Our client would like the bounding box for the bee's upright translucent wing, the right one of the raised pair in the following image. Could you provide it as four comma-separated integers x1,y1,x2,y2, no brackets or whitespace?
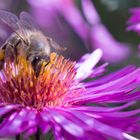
19,11,39,31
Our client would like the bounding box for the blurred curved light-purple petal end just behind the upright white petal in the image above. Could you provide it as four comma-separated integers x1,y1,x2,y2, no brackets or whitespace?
91,24,130,63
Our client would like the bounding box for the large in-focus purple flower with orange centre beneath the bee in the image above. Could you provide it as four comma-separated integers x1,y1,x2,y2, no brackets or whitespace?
0,49,140,140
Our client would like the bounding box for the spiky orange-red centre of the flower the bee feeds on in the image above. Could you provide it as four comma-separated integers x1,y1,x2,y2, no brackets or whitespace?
0,53,79,109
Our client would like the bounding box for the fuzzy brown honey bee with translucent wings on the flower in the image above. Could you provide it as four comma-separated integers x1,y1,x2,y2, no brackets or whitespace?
0,10,64,71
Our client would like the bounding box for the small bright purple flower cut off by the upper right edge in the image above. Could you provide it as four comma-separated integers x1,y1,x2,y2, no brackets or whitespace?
127,7,140,33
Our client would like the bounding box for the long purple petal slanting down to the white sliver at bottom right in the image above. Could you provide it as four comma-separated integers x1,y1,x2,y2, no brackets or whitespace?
55,108,123,139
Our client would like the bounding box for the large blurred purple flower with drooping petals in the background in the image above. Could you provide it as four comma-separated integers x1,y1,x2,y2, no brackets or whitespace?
28,0,129,63
